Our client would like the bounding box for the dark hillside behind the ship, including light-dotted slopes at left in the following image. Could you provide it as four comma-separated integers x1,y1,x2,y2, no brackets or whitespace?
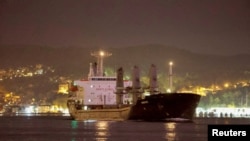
0,45,250,105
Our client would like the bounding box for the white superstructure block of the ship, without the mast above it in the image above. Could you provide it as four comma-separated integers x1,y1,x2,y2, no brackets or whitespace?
74,77,131,105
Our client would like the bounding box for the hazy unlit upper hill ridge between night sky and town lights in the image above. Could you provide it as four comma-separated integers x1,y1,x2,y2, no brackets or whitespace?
0,44,250,81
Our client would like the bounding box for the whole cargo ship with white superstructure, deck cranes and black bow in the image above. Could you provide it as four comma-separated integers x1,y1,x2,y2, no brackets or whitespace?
67,51,201,121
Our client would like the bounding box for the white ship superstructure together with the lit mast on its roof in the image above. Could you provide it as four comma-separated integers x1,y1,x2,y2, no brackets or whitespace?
72,51,132,106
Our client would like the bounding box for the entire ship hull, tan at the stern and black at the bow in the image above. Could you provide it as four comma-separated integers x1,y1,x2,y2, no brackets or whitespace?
68,93,201,121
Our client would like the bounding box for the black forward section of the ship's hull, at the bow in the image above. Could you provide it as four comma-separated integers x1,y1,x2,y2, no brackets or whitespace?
129,93,201,120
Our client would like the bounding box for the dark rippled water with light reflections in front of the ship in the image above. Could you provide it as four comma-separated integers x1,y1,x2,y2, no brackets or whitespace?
0,116,250,141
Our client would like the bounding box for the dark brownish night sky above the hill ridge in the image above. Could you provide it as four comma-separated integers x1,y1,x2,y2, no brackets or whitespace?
0,0,250,54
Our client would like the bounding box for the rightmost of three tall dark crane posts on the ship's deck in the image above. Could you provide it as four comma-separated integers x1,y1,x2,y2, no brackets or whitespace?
149,64,158,94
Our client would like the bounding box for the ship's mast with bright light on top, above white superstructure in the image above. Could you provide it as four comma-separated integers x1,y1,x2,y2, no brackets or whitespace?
91,51,112,76
